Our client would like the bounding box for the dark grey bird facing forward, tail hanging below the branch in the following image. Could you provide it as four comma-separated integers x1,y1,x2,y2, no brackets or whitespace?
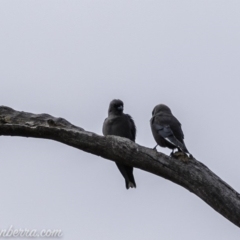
102,99,136,189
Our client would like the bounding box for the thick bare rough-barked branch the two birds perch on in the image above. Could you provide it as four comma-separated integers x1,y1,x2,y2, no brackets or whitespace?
0,106,240,227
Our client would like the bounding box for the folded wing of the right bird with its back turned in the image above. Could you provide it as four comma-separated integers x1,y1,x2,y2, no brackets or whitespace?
153,122,187,152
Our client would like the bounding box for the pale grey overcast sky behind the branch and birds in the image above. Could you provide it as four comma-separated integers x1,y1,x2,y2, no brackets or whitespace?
0,0,240,240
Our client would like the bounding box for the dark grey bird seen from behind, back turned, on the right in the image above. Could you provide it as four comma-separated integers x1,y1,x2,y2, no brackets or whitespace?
150,104,191,156
